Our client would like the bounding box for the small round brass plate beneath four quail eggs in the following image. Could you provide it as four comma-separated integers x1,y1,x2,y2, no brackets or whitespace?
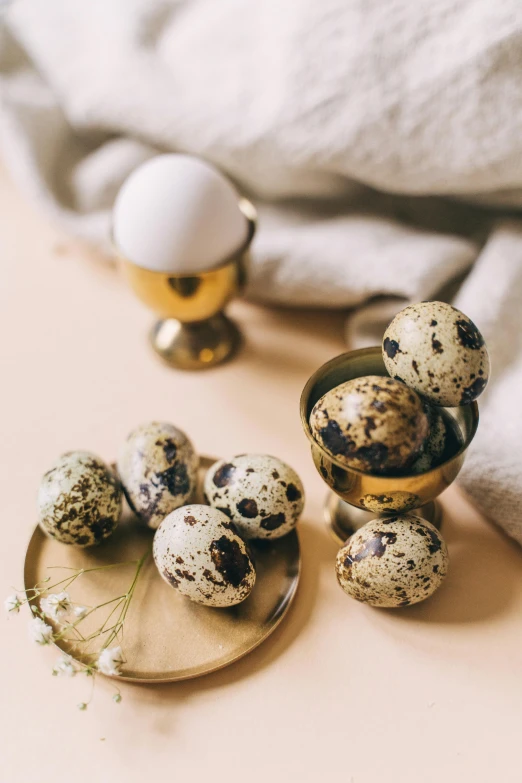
24,457,301,683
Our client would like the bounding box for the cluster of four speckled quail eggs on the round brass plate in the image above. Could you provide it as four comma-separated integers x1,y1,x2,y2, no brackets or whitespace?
38,422,304,607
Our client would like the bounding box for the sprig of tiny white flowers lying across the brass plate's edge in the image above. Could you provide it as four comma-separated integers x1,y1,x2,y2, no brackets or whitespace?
4,549,150,711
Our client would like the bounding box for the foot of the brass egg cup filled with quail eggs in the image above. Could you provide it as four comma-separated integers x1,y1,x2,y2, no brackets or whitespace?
324,492,442,544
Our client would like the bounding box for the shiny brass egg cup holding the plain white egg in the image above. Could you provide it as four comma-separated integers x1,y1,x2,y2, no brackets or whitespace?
119,198,256,370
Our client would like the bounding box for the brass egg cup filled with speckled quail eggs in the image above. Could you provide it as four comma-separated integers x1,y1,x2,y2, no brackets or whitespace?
300,347,479,542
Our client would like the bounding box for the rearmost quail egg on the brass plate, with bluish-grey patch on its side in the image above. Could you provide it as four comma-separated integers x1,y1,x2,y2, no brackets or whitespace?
118,421,199,529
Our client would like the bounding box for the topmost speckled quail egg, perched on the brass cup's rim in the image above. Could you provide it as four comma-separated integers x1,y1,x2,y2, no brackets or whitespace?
383,302,490,407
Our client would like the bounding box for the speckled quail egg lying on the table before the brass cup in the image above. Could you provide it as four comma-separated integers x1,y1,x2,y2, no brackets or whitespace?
335,514,449,607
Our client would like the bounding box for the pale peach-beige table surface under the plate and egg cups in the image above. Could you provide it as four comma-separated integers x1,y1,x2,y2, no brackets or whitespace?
0,164,522,783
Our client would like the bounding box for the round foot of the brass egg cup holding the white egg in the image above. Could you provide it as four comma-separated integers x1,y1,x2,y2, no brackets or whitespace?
149,313,242,370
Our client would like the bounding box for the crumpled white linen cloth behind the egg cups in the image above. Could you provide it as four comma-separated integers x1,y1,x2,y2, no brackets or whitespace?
0,0,522,543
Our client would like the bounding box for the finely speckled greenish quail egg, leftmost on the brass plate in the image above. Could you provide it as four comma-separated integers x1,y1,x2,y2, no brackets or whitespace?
38,451,122,547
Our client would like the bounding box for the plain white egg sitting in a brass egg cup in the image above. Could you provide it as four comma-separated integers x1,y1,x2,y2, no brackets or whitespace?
113,155,248,274
